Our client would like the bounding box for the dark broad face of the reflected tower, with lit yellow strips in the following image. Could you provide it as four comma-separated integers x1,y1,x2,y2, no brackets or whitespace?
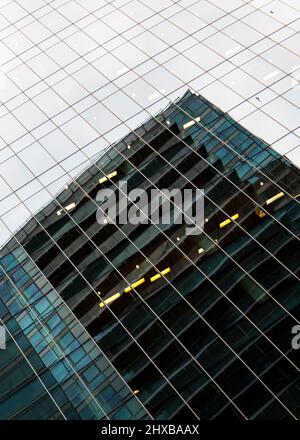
3,92,300,419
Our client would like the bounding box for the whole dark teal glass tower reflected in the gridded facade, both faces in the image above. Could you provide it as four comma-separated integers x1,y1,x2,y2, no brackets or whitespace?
0,91,300,420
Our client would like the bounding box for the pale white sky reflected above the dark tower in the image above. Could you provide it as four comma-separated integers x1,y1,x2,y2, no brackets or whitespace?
0,0,300,243
